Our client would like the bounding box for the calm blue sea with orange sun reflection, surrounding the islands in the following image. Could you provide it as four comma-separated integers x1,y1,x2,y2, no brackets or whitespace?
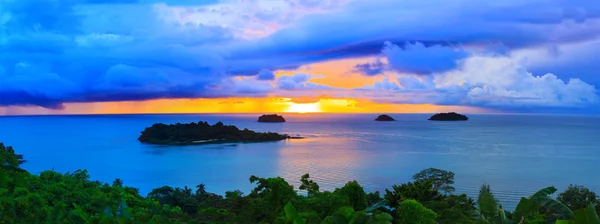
0,114,600,209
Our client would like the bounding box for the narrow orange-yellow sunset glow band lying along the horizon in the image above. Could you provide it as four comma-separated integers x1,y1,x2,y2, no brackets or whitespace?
0,98,502,115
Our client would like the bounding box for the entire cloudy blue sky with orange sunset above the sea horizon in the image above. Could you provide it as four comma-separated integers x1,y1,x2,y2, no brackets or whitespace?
0,0,600,115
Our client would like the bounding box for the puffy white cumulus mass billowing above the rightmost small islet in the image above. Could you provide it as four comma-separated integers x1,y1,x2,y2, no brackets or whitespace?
436,56,599,107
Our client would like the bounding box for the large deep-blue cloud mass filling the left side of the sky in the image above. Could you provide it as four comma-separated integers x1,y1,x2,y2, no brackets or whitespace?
0,0,356,108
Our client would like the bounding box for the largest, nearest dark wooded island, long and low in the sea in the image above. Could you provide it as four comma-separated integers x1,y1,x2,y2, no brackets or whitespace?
138,122,292,145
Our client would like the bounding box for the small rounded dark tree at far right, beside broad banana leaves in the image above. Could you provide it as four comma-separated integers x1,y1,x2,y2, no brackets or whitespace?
556,184,600,213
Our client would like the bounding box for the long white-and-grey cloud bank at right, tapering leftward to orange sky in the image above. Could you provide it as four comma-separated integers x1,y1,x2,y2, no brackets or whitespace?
357,51,600,111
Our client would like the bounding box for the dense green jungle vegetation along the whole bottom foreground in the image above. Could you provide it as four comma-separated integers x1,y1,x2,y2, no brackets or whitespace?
0,143,600,224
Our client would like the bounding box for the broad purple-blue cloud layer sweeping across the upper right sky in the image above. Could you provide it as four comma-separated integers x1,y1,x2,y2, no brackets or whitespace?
232,0,600,72
